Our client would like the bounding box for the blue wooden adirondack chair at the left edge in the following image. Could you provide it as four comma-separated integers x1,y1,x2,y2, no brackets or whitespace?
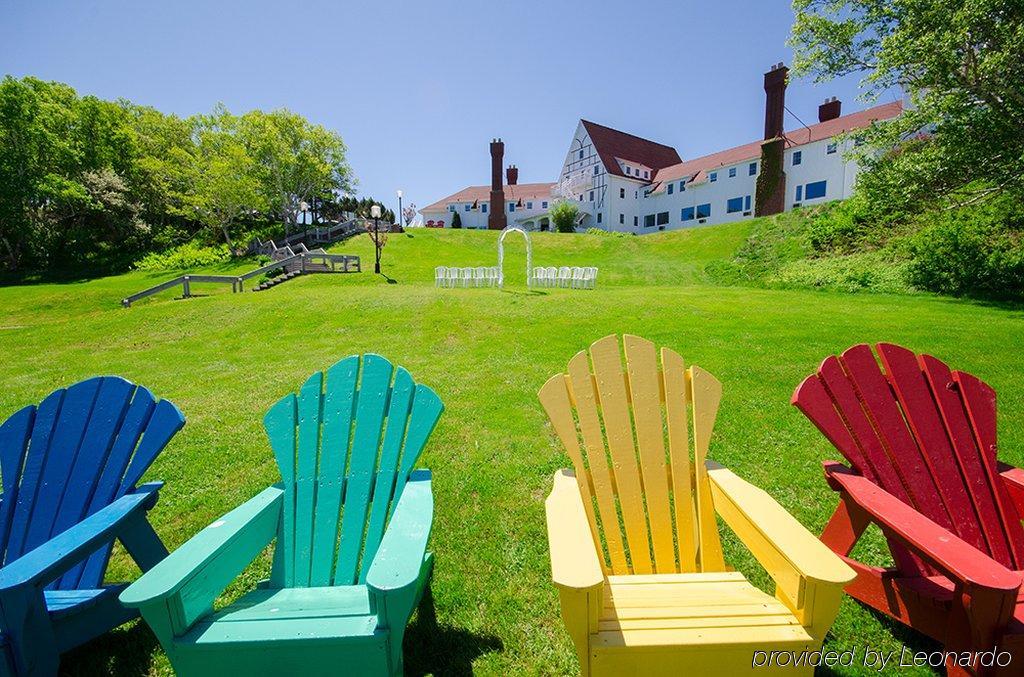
0,376,185,675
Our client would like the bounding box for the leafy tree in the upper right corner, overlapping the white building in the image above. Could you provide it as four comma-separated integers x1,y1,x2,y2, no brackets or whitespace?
790,0,1024,211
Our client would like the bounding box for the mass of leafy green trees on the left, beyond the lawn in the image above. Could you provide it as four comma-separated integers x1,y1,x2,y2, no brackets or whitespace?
0,76,356,270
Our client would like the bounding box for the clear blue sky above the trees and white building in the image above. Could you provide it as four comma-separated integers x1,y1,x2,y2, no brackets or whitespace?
0,0,891,215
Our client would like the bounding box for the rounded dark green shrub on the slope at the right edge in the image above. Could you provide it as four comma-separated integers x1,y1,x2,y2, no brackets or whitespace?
907,199,1024,299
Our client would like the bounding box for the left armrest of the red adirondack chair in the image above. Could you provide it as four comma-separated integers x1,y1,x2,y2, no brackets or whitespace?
824,462,1021,595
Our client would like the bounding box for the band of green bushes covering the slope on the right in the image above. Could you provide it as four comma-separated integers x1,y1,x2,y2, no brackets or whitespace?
707,195,1024,301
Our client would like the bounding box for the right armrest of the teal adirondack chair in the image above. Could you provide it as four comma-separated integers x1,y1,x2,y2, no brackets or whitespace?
367,470,434,594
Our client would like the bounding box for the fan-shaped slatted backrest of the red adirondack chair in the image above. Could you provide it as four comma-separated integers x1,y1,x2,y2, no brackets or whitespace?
793,344,1024,576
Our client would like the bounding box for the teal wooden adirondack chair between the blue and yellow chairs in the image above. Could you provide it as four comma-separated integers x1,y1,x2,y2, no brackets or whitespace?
121,354,443,677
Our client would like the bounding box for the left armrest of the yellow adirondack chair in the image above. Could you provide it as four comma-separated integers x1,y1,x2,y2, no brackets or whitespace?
544,470,604,590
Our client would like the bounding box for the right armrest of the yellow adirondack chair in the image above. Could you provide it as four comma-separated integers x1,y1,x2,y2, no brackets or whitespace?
707,461,856,636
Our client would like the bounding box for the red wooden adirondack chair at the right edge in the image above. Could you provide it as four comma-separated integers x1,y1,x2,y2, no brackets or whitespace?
793,343,1024,674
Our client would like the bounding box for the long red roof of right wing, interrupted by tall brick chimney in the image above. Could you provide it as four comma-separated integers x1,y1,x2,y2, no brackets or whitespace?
651,101,903,189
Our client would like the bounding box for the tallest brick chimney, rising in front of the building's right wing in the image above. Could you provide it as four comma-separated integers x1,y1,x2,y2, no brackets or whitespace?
754,64,790,216
